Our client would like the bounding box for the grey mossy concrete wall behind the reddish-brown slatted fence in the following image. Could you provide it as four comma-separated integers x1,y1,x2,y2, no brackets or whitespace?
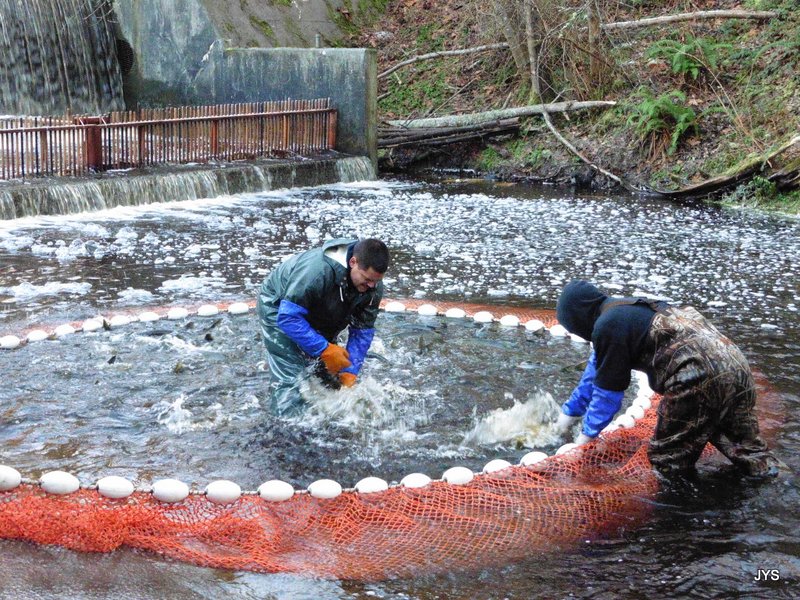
114,0,377,169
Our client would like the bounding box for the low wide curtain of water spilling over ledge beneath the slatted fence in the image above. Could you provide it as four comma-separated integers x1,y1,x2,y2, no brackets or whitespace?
0,156,375,220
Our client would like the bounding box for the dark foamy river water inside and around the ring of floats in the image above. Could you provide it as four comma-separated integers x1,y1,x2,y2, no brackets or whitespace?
0,179,800,599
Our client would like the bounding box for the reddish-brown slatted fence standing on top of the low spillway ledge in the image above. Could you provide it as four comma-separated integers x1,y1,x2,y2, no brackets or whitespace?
0,98,337,179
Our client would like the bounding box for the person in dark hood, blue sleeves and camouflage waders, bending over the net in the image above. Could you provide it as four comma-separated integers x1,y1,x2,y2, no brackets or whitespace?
556,280,783,476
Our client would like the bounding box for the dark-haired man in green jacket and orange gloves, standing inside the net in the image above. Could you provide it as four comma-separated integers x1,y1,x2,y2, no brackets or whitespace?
258,238,389,415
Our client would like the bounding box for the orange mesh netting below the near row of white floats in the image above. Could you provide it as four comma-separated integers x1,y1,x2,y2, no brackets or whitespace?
0,404,657,580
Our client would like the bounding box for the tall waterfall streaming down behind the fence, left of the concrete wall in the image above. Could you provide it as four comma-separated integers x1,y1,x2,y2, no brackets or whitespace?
0,0,124,115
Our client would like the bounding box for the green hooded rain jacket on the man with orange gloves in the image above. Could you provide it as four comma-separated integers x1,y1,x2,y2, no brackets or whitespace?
259,238,383,342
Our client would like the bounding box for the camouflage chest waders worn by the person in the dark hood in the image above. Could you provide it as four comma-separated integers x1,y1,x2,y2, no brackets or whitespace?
604,300,780,476
